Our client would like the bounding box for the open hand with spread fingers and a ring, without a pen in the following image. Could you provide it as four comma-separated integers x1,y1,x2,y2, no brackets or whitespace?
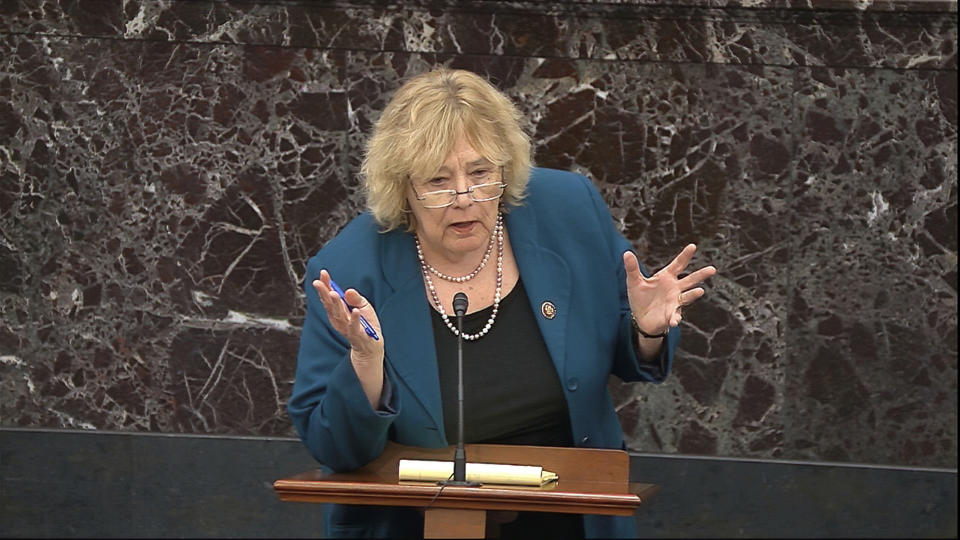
623,244,717,335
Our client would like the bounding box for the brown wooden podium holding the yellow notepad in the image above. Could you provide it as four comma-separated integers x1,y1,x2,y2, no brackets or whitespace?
273,443,659,538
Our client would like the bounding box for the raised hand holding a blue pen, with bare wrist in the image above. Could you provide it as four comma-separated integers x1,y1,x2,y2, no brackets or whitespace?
312,270,384,409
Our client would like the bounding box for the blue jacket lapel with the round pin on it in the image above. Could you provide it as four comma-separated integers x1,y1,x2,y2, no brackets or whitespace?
505,205,572,378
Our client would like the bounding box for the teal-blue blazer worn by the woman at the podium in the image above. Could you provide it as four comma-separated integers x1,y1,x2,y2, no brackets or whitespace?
287,169,680,537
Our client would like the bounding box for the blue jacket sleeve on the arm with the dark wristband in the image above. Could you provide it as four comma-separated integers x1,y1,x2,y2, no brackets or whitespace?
580,176,680,383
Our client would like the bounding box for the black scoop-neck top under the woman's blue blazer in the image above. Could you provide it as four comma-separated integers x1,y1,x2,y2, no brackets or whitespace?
433,280,573,446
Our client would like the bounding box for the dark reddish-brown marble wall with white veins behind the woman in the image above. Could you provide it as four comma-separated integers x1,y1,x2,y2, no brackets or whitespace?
0,0,957,468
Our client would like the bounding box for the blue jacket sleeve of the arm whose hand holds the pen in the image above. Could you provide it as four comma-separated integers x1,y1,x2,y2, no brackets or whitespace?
287,256,400,471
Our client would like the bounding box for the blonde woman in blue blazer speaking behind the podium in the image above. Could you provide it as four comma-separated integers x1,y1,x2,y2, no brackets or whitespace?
288,68,715,537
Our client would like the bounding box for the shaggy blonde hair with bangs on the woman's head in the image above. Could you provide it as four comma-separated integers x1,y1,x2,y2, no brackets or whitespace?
361,67,532,231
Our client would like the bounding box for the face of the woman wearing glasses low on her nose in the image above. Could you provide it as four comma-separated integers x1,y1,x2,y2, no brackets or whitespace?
407,137,502,264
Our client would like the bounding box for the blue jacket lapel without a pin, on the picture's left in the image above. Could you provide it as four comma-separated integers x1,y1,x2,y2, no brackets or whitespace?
376,230,446,441
